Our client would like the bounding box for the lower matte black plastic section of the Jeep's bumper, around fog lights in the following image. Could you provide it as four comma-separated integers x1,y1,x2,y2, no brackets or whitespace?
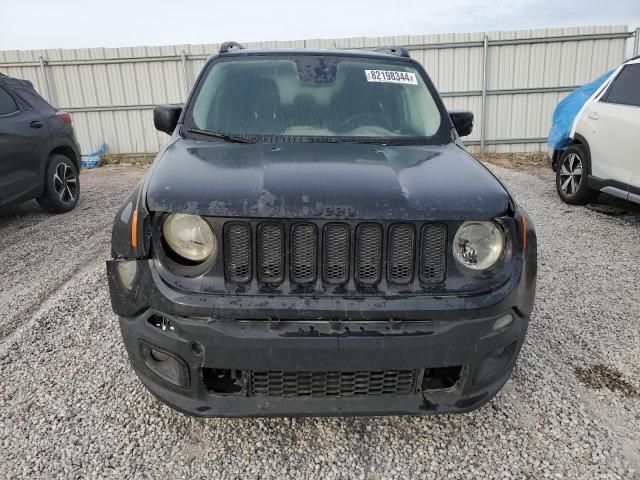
120,311,528,416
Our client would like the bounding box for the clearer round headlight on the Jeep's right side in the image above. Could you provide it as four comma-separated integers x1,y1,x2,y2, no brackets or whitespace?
453,222,505,270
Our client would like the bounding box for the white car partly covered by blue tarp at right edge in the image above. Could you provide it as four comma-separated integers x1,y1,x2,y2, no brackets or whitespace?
551,57,640,204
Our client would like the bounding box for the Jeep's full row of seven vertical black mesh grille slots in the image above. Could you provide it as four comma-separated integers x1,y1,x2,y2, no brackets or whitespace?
222,220,447,293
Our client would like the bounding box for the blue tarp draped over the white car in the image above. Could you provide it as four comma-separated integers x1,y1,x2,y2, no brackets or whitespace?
547,70,613,150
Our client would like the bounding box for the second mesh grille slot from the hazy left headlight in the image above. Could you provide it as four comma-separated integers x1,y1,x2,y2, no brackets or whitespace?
258,223,284,285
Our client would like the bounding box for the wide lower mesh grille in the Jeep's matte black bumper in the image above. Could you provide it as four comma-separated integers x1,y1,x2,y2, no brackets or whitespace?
249,370,418,397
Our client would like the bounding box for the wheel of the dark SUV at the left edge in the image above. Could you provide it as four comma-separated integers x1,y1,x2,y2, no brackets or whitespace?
38,155,80,213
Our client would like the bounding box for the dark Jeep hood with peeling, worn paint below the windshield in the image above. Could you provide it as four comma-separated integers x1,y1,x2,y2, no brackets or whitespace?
146,140,509,220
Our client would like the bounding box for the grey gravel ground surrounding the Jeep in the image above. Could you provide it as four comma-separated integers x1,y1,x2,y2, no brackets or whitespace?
0,166,640,479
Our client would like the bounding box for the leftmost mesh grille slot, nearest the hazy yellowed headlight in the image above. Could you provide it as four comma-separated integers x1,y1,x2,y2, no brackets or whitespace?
224,222,252,283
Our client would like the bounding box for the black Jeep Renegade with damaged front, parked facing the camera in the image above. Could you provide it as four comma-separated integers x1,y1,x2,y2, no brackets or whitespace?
107,43,536,416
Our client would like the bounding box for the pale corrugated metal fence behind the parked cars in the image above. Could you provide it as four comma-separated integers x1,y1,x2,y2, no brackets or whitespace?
0,26,640,153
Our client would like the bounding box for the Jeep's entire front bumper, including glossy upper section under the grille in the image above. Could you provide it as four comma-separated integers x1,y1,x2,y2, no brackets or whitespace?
107,260,535,416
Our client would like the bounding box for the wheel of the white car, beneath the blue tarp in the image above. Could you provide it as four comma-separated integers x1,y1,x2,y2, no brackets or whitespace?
556,145,598,205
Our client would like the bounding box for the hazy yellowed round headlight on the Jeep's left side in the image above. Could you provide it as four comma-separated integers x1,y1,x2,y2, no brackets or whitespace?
162,213,218,262
